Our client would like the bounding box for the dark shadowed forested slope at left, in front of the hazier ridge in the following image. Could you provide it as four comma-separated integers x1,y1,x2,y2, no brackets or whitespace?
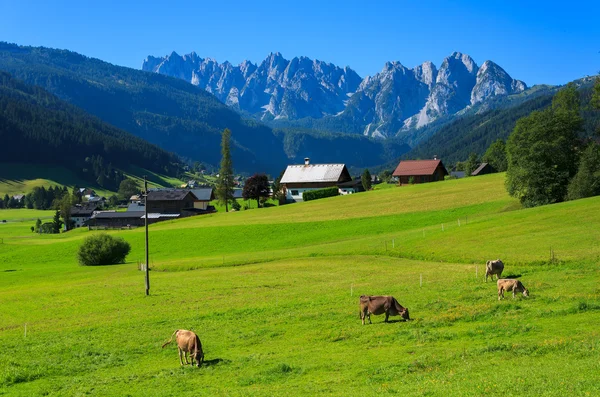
0,72,180,190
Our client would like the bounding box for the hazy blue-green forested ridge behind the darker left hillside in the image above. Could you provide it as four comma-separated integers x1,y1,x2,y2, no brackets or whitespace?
0,43,407,174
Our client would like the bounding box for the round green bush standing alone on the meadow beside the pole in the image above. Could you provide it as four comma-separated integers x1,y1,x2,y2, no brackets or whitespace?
77,233,131,266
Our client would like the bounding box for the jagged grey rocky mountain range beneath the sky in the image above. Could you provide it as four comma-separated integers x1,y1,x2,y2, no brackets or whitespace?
142,52,527,138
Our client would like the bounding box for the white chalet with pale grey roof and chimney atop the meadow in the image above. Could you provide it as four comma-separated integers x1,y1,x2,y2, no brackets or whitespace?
281,157,352,202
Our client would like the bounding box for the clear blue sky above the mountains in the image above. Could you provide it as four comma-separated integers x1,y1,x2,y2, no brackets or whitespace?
0,0,600,85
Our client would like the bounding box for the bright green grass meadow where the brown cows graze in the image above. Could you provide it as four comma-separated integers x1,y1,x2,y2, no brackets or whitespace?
0,174,600,396
